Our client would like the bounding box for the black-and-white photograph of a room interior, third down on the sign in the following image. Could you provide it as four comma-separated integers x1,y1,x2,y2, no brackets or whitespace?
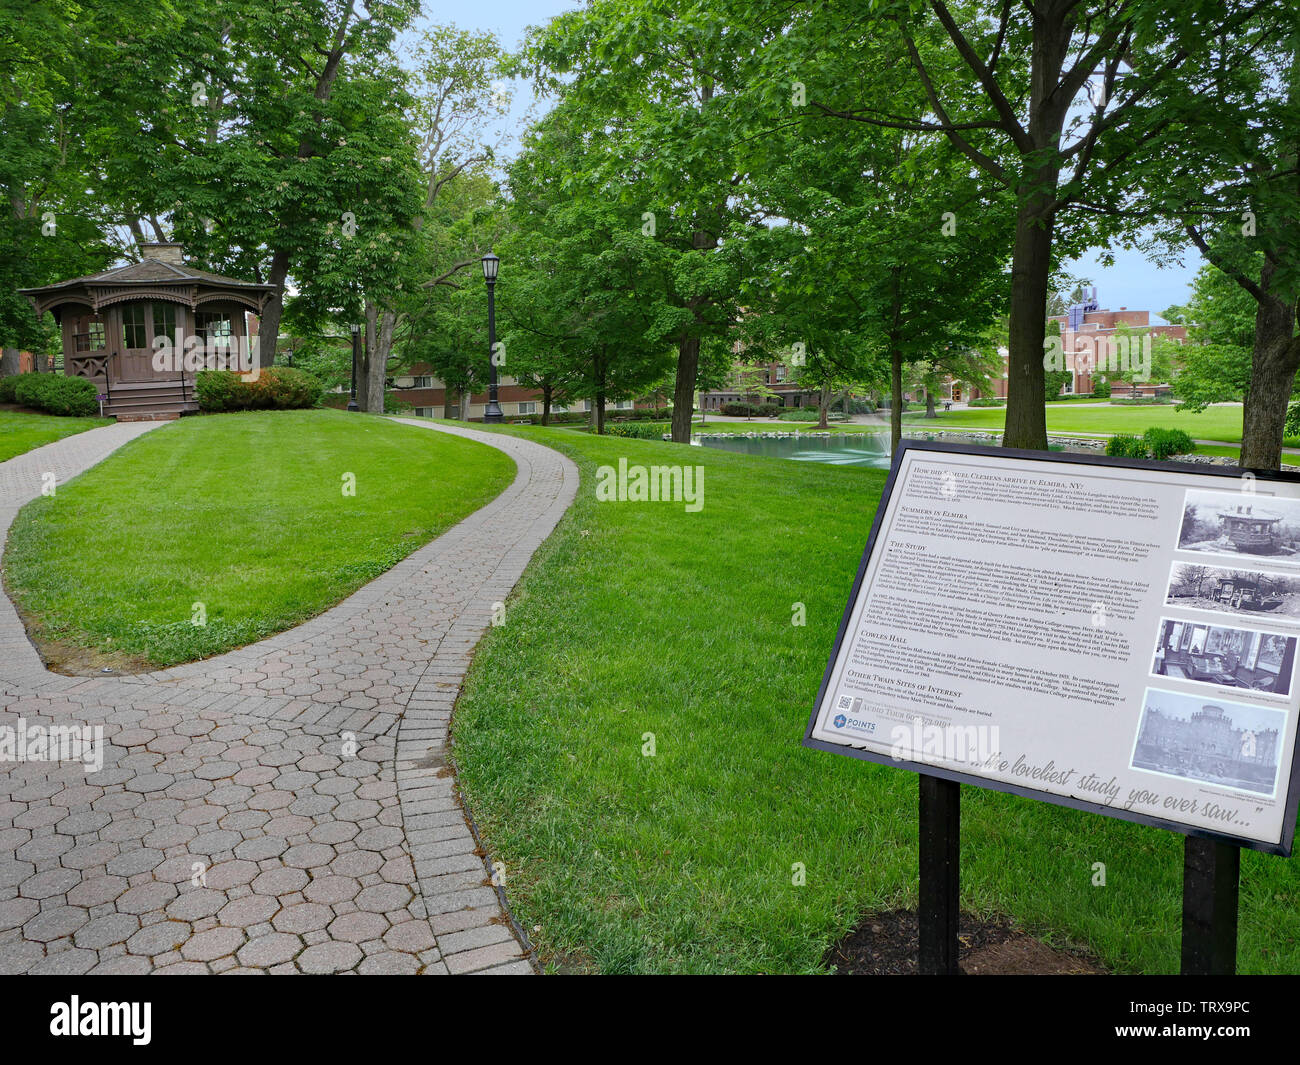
1151,618,1296,696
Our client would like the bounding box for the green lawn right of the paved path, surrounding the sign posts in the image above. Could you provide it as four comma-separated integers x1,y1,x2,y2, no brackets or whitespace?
454,429,1300,973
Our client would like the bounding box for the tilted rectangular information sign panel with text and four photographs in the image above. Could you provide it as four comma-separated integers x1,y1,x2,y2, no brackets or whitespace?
805,441,1300,854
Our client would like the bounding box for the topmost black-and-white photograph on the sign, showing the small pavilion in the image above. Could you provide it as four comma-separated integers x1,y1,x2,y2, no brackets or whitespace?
1178,481,1300,566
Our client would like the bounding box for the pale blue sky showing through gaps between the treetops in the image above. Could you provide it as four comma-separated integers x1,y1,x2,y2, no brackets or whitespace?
410,0,1203,322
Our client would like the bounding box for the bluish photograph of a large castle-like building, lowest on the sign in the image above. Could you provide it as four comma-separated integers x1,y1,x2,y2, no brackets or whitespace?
1132,688,1287,796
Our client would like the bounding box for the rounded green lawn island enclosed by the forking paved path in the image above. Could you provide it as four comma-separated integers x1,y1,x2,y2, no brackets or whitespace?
4,411,515,667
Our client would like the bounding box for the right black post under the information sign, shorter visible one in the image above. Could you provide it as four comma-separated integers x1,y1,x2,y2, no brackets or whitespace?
1183,836,1242,977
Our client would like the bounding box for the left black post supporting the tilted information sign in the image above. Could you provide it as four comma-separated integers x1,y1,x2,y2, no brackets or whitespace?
918,774,962,975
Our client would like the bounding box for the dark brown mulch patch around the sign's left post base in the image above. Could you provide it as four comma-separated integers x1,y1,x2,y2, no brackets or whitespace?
823,910,1106,977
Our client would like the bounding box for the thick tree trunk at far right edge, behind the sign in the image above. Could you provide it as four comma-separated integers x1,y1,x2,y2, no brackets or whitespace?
1240,259,1300,469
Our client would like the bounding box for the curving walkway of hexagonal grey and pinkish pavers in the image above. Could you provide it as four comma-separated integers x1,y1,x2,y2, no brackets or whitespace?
0,419,577,974
